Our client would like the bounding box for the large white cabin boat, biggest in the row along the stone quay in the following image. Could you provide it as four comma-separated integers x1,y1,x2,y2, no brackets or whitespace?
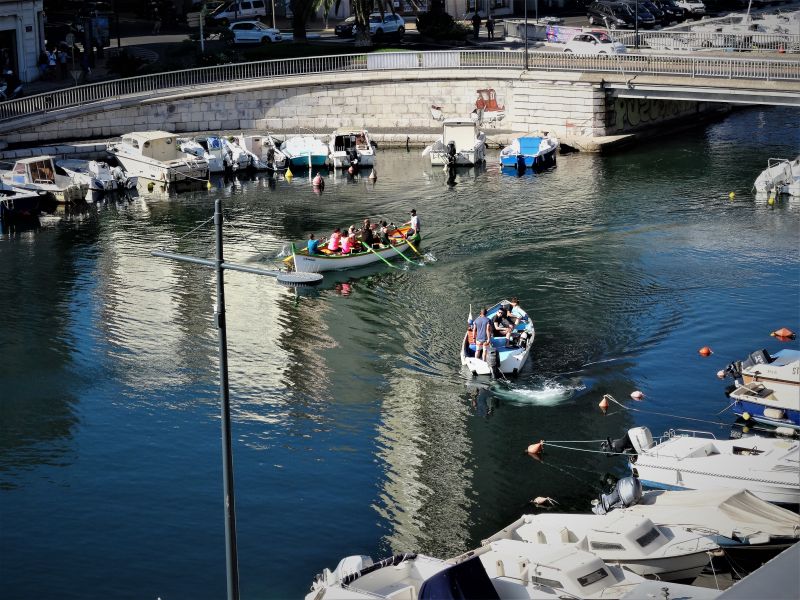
108,131,208,185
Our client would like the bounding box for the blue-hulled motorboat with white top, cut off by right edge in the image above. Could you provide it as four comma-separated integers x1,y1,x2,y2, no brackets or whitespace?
722,348,800,429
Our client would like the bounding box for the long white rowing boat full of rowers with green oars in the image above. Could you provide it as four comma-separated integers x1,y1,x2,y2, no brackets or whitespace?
284,210,422,273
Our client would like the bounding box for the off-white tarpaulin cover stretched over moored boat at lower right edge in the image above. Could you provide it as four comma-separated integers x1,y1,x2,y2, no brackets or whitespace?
623,489,800,543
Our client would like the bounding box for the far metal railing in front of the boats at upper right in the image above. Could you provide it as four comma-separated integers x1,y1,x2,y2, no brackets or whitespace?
615,31,800,52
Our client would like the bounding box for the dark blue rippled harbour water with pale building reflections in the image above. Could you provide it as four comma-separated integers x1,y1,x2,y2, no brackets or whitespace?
0,109,800,600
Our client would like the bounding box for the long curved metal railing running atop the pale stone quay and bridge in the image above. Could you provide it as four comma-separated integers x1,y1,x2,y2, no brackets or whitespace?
0,50,800,122
